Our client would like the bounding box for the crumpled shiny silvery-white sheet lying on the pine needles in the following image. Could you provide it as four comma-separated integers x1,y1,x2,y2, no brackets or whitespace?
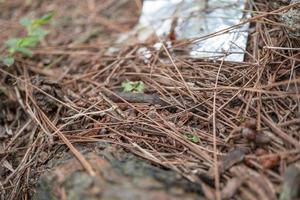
123,0,250,62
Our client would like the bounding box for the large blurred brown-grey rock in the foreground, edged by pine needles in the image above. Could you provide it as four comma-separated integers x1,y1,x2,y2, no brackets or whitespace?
33,147,203,200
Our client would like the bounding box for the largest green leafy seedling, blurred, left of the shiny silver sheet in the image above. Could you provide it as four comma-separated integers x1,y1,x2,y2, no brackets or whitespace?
1,12,54,66
